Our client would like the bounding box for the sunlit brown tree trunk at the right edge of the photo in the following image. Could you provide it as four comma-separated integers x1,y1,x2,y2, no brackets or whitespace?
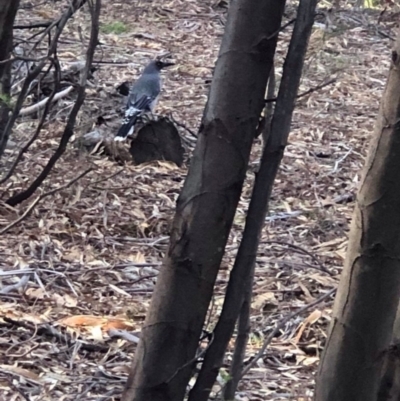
315,32,400,401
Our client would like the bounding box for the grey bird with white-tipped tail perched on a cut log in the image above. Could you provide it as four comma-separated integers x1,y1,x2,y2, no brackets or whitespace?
114,60,174,141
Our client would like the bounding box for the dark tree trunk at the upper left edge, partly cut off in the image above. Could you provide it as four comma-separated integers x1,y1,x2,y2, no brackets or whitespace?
0,0,19,158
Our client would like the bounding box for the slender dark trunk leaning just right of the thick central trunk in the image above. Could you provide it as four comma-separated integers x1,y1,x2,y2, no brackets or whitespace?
189,0,317,401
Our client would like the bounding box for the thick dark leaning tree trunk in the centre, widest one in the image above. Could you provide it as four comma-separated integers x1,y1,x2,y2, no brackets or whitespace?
123,0,284,401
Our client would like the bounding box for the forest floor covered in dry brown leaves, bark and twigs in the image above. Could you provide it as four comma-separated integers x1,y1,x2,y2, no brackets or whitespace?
0,0,395,401
